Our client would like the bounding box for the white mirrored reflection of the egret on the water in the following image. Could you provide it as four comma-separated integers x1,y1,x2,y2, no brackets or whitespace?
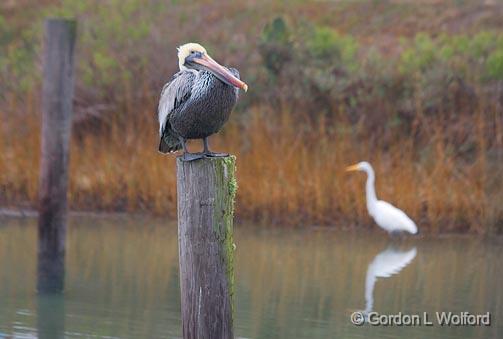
364,245,417,314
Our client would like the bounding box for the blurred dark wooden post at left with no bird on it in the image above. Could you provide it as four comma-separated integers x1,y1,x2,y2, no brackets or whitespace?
37,19,76,293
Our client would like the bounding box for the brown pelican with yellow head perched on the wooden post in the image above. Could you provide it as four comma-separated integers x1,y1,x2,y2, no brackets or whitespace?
158,43,248,161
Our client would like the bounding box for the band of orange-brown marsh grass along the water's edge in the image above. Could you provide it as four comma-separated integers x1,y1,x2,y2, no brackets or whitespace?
0,97,503,233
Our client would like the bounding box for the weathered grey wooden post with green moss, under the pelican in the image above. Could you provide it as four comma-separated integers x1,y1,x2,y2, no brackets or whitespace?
177,156,237,339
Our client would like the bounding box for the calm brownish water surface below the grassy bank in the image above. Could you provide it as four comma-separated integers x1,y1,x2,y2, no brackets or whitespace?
0,217,503,338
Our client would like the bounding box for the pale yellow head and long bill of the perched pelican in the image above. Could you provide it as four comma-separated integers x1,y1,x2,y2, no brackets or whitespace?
178,42,248,92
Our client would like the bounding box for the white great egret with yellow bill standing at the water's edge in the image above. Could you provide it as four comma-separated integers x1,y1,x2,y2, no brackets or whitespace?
346,161,417,234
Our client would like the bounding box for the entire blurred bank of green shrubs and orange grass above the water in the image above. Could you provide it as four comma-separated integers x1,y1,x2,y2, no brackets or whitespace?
0,0,503,233
